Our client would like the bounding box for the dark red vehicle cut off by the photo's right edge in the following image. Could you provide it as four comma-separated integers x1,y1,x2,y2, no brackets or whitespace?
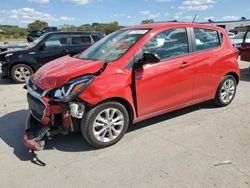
240,26,250,61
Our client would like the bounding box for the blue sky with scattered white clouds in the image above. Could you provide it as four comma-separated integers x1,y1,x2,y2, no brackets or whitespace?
0,0,250,27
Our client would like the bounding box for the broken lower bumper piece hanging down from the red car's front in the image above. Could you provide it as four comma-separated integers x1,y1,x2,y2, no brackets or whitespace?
23,114,50,151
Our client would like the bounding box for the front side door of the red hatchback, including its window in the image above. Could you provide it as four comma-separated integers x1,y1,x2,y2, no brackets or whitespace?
135,28,194,117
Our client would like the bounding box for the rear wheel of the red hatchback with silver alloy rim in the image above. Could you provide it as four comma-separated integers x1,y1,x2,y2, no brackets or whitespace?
214,75,237,107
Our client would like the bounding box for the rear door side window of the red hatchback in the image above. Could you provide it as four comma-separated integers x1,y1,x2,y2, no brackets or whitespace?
194,28,221,51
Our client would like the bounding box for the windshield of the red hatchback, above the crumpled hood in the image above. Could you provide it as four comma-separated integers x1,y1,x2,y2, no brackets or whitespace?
77,29,148,61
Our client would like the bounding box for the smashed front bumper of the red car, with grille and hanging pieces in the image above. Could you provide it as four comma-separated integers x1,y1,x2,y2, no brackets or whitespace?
23,78,74,151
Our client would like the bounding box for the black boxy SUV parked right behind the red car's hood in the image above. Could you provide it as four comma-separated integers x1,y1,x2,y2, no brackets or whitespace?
0,32,104,83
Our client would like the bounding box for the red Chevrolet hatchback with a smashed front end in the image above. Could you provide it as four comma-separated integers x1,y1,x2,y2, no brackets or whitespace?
24,22,240,150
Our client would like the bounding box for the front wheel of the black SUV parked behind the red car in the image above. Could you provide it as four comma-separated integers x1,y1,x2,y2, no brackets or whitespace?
10,64,34,83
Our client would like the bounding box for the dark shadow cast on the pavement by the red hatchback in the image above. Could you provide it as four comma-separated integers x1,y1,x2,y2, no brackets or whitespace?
0,102,214,161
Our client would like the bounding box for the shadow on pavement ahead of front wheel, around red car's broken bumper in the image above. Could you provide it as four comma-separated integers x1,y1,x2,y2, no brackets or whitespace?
0,110,93,161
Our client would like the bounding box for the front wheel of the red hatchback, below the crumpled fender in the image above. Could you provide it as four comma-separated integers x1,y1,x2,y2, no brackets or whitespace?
81,102,129,148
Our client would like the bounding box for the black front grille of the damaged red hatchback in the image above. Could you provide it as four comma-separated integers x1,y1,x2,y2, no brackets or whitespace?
27,93,46,121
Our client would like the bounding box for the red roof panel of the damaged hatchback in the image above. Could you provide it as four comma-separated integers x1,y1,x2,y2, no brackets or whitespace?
124,22,224,31
